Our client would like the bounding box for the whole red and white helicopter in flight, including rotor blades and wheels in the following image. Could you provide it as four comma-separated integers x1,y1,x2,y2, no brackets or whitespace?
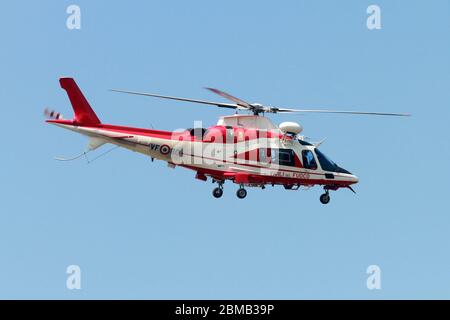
45,78,409,204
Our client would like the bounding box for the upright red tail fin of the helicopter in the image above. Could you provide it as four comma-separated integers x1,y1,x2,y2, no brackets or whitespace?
59,78,100,125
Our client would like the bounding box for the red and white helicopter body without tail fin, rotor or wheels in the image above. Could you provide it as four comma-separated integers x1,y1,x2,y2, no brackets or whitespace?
48,116,358,190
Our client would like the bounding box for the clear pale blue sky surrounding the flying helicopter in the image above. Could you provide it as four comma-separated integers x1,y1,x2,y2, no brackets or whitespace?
0,0,450,299
